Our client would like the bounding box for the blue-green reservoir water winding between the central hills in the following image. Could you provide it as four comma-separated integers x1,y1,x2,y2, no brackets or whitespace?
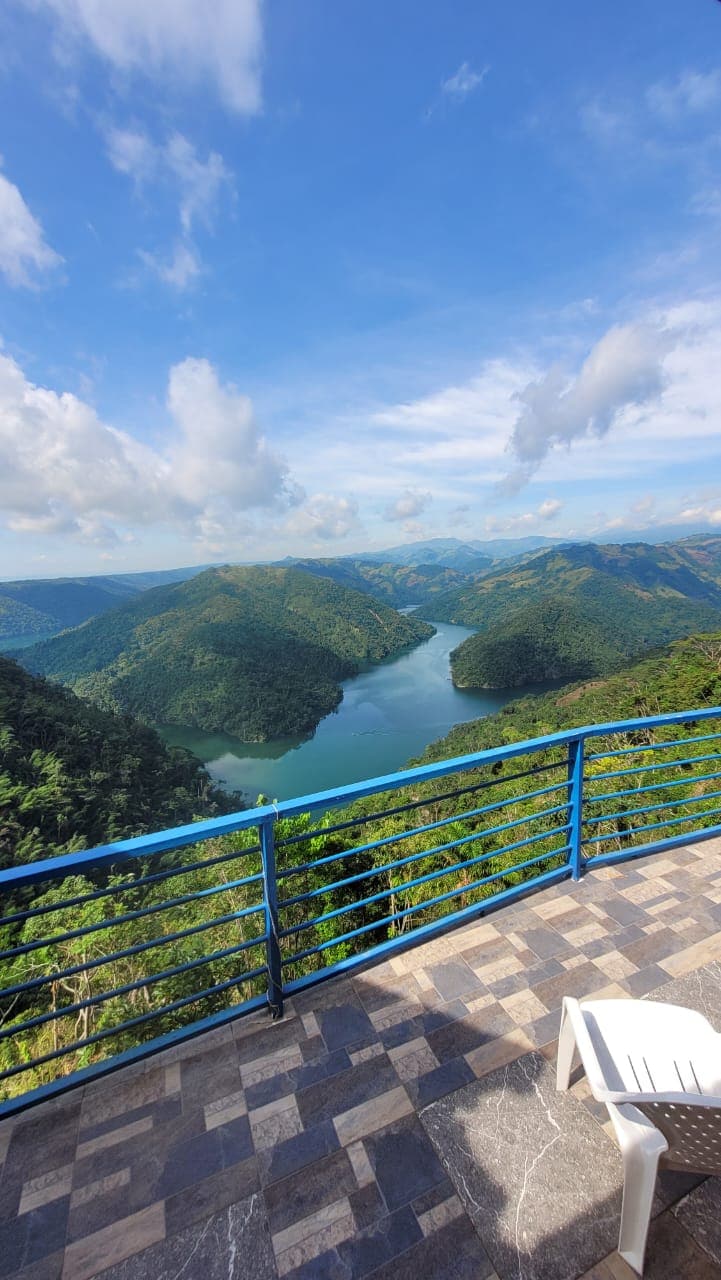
160,622,537,804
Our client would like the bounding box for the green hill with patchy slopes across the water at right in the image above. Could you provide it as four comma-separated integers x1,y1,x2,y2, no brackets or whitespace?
421,538,721,687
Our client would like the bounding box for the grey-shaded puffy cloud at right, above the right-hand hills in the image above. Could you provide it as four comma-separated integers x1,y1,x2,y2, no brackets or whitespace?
503,324,671,493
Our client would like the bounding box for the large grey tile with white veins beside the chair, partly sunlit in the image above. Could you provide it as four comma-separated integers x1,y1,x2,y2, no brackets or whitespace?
421,1053,622,1280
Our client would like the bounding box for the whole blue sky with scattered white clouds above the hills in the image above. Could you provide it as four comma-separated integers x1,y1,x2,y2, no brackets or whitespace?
0,0,721,577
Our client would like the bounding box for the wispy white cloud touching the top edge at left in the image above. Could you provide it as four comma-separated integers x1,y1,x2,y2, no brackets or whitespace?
26,0,263,115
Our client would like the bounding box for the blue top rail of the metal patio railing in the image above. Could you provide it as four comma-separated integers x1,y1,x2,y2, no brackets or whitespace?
0,707,721,891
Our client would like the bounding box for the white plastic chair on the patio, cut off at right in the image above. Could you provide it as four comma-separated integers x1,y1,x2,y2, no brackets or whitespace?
556,996,721,1275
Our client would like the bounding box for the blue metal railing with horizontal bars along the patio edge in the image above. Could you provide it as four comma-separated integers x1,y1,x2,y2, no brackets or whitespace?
0,708,721,1114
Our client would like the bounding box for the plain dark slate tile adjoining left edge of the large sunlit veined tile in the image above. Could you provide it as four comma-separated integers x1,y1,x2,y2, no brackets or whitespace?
364,1116,446,1211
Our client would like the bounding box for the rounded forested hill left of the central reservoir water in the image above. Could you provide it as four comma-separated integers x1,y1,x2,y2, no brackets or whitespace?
20,566,433,741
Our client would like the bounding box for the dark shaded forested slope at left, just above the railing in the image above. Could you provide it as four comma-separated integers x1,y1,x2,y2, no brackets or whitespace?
0,657,233,867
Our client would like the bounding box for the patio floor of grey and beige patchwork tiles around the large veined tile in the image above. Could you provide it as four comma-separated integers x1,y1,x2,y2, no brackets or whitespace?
0,841,721,1280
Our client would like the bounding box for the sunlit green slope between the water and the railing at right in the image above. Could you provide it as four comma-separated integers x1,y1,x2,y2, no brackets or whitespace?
412,631,721,764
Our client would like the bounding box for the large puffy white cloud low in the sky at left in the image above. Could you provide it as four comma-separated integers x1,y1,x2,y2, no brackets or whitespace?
0,355,291,541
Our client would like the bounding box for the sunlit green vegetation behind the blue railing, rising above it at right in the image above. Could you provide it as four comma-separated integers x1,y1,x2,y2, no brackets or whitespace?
0,632,721,1093
